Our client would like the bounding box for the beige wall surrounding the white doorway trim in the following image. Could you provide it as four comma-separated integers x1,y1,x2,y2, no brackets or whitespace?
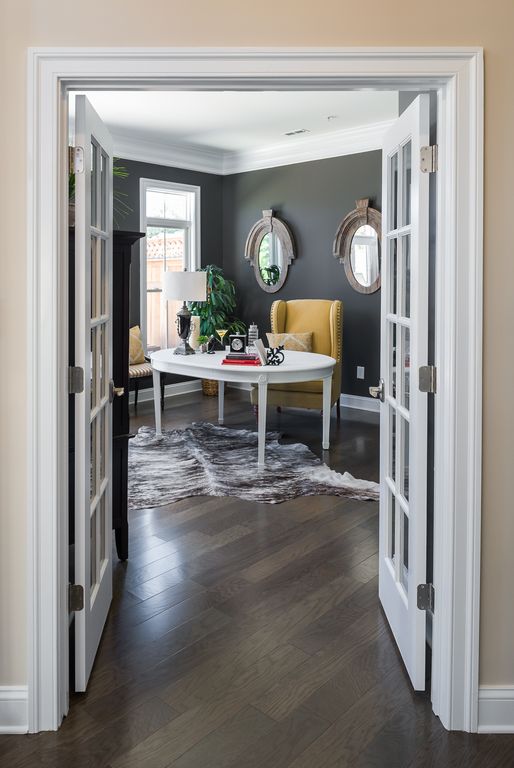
0,0,514,685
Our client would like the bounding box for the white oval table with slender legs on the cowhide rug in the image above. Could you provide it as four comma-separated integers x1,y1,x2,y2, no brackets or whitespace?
150,349,336,467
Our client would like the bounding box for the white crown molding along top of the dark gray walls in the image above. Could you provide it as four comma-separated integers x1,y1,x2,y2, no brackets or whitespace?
112,120,394,176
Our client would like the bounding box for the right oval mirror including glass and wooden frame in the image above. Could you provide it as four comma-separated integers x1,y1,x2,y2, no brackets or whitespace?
333,198,382,293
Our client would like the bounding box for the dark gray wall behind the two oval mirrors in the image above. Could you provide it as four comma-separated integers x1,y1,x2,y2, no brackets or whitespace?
223,151,382,395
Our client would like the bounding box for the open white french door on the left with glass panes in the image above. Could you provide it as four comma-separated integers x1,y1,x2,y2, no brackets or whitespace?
75,96,112,691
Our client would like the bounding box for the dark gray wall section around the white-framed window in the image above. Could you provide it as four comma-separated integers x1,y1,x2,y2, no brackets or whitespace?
114,159,223,325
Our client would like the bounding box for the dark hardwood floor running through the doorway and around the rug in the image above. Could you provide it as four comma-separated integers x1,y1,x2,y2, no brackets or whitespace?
4,390,514,768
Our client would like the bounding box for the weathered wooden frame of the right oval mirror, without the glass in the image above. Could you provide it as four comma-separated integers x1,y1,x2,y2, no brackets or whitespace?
333,197,382,293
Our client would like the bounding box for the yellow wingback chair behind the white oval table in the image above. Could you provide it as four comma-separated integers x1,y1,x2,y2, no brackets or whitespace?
251,299,343,419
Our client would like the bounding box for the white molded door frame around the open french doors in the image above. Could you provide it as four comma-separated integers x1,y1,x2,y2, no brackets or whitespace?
27,48,483,732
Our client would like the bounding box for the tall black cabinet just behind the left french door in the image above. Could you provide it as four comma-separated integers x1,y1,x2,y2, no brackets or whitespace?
112,230,144,560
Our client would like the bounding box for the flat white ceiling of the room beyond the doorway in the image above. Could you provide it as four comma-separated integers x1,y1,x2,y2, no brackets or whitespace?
74,91,398,152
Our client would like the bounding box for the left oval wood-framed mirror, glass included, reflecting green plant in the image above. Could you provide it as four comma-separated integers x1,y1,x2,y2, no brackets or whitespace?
245,209,296,293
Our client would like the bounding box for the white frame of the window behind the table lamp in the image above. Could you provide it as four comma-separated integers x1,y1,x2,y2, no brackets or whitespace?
139,178,201,352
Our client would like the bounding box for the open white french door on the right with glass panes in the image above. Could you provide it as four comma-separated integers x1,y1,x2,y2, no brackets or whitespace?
379,95,430,690
